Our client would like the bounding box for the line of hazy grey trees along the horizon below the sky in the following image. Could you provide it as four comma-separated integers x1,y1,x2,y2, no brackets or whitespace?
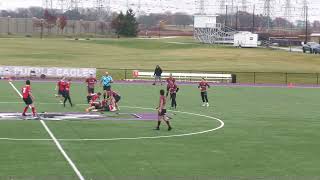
0,7,320,35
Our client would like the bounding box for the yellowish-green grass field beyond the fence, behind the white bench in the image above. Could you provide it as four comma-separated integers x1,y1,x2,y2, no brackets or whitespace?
0,38,320,73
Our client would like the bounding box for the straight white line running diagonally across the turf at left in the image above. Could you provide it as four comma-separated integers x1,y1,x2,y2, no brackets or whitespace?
9,82,85,180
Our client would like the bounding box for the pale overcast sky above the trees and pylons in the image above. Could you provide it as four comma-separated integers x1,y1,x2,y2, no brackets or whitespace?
0,0,320,20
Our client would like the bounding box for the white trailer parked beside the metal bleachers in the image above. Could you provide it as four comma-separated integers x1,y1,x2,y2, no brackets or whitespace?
233,31,258,47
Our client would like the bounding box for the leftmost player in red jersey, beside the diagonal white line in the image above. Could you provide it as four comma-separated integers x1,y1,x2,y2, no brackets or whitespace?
22,80,36,117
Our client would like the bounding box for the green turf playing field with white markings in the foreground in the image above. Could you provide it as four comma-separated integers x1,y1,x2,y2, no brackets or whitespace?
0,81,320,180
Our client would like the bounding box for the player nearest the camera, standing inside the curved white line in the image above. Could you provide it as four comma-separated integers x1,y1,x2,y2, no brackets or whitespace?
155,89,172,131
